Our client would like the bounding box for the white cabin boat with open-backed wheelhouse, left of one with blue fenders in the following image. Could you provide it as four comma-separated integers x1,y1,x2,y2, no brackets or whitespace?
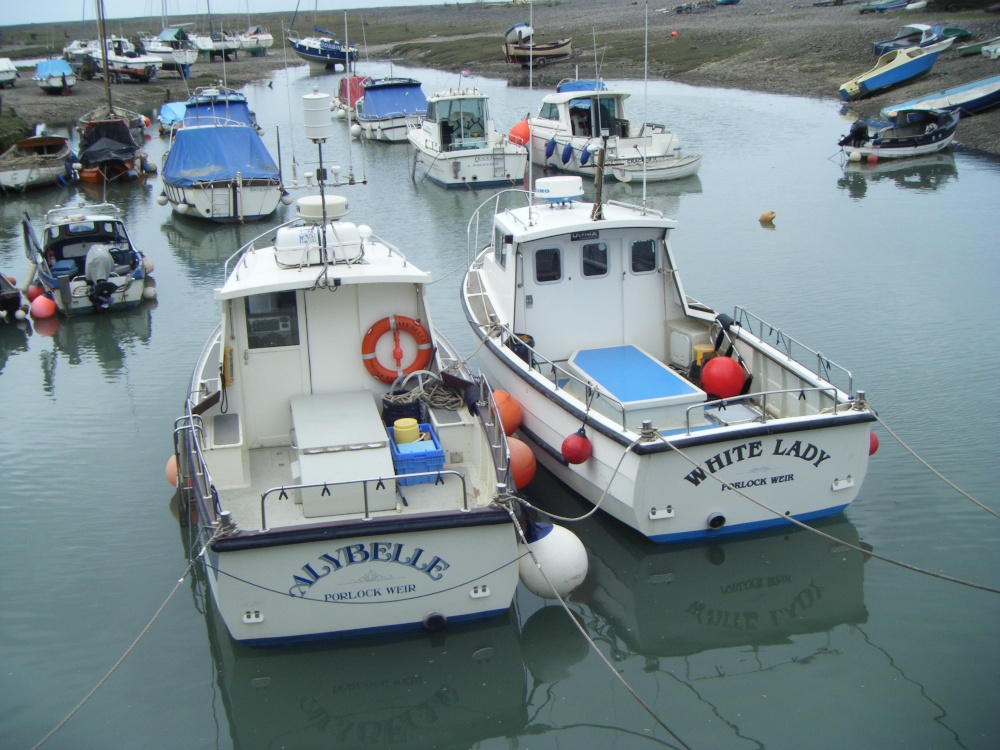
407,88,528,187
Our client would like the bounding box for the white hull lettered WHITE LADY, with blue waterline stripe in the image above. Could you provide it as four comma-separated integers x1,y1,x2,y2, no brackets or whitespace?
477,343,871,543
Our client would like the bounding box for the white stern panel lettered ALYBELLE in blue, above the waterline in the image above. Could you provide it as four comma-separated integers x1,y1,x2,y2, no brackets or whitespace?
199,511,518,646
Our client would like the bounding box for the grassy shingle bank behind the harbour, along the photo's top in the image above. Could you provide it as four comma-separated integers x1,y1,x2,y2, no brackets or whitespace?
0,0,1000,155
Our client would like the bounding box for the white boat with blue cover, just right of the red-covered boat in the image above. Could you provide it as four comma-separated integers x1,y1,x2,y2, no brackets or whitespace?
352,78,427,143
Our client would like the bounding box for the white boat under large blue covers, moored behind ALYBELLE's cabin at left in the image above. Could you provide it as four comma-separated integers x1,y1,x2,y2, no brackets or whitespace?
159,88,287,222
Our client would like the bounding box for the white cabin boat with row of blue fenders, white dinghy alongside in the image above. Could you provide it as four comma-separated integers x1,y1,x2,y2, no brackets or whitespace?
514,80,701,182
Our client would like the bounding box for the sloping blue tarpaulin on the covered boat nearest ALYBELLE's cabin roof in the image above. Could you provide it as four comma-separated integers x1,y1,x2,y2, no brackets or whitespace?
163,122,279,187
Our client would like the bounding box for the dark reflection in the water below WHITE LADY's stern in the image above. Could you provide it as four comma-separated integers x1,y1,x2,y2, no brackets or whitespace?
528,470,868,674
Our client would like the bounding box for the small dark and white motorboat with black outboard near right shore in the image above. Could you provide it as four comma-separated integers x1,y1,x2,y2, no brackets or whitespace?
837,109,960,161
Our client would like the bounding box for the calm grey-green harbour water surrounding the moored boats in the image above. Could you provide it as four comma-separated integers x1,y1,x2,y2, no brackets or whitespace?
0,65,1000,750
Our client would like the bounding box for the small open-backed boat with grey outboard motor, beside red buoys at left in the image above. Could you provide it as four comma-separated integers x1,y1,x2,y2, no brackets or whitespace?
22,203,155,316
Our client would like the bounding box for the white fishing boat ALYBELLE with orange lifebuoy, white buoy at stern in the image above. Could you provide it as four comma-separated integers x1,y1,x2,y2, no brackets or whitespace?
168,93,586,645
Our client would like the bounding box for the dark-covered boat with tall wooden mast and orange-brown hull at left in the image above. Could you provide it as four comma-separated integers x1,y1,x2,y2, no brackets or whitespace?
77,0,155,182
